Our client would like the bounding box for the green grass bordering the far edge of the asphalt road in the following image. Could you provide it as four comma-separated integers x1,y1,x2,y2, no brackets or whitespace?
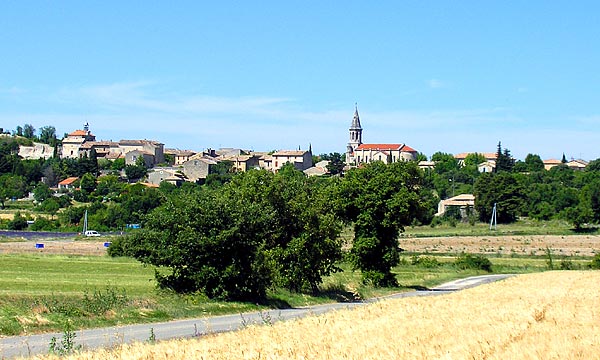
0,250,556,336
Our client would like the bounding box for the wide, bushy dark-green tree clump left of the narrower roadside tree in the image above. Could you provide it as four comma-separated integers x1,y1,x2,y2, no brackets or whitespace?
111,167,341,301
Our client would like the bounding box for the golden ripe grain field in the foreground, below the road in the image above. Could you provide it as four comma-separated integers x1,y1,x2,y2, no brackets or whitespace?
37,271,600,359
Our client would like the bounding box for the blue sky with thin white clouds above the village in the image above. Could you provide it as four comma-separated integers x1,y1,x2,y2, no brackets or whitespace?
0,0,600,160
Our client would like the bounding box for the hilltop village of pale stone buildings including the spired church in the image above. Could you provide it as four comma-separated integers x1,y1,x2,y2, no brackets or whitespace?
9,107,588,188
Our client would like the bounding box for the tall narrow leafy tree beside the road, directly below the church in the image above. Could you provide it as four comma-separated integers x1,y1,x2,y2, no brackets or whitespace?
336,162,429,286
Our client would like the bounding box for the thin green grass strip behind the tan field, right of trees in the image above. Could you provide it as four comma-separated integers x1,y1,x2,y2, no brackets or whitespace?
401,219,598,237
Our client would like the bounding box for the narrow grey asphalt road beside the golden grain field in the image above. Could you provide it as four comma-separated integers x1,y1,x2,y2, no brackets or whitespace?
0,274,513,359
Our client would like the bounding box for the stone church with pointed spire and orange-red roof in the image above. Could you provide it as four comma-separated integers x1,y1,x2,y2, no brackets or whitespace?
346,106,417,166
